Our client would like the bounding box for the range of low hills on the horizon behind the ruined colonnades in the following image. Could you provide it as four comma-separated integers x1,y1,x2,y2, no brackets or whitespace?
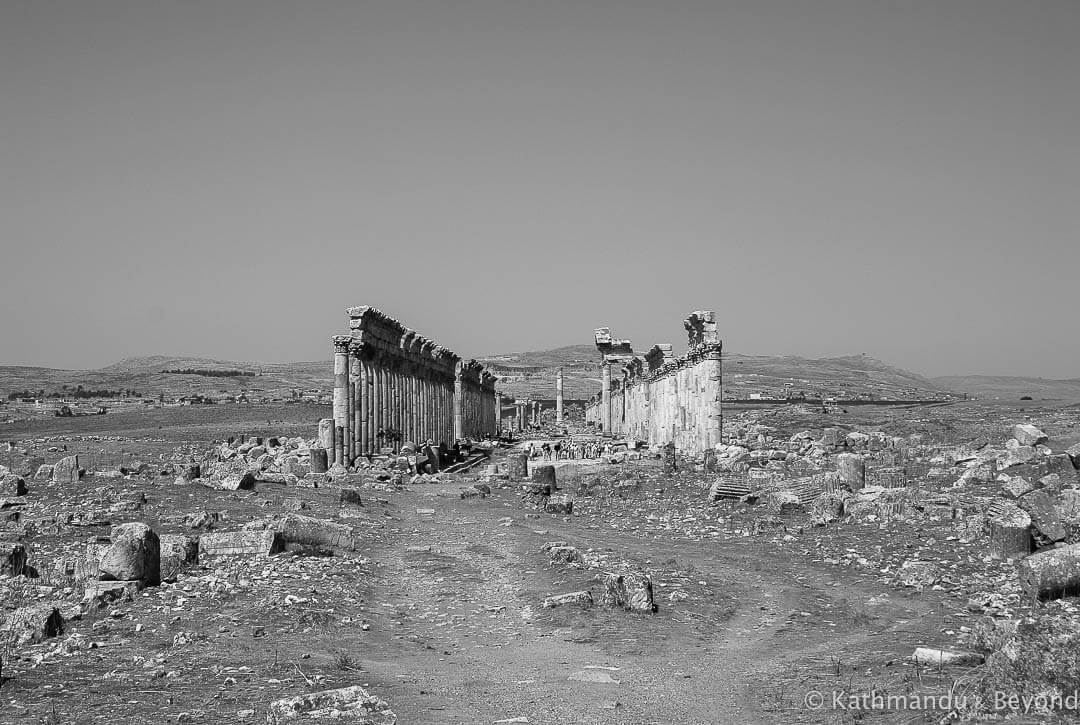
0,345,972,400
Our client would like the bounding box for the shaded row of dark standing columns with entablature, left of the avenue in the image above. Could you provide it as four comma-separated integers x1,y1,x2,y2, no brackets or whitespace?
327,306,499,466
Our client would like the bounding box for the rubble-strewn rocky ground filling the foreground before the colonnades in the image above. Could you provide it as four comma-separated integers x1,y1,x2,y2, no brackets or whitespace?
0,404,1080,723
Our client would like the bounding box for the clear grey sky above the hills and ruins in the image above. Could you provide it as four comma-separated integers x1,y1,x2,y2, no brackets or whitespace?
0,0,1080,378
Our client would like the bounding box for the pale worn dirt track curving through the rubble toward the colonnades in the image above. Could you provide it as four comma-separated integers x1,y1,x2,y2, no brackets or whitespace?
347,486,929,723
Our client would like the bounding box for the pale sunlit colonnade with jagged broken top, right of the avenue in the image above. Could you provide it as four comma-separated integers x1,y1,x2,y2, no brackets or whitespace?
585,310,724,454
